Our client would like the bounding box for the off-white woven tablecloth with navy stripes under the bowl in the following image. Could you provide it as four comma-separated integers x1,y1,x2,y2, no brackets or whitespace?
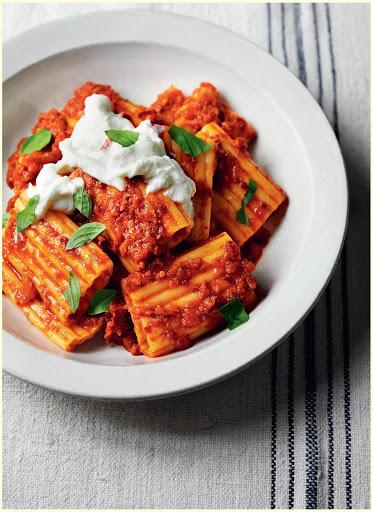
3,4,370,508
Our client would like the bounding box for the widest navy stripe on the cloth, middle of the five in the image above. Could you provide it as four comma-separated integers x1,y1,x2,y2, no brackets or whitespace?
294,4,318,508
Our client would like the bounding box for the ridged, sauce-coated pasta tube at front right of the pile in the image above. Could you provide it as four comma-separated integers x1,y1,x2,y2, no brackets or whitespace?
122,233,255,357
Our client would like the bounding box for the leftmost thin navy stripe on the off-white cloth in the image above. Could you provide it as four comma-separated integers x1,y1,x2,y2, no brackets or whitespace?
267,4,277,509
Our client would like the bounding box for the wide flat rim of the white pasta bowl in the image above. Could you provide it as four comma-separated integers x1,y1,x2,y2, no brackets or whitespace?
3,9,348,400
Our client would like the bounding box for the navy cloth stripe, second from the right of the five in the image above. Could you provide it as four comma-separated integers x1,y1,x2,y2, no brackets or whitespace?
312,4,334,509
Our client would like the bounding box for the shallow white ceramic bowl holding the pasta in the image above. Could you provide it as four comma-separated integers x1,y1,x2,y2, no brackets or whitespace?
3,10,348,400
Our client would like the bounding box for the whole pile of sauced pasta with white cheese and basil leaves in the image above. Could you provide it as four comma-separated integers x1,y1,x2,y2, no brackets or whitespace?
2,82,287,357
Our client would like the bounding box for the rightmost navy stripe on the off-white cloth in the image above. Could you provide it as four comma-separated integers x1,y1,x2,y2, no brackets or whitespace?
325,4,352,509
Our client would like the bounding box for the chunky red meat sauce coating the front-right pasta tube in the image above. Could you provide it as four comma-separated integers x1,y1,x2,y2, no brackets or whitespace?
122,242,256,350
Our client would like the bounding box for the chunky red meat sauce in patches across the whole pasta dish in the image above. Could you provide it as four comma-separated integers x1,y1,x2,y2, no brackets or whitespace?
4,82,264,355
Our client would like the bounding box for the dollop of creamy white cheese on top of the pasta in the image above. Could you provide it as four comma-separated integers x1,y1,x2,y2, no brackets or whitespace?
27,94,195,219
